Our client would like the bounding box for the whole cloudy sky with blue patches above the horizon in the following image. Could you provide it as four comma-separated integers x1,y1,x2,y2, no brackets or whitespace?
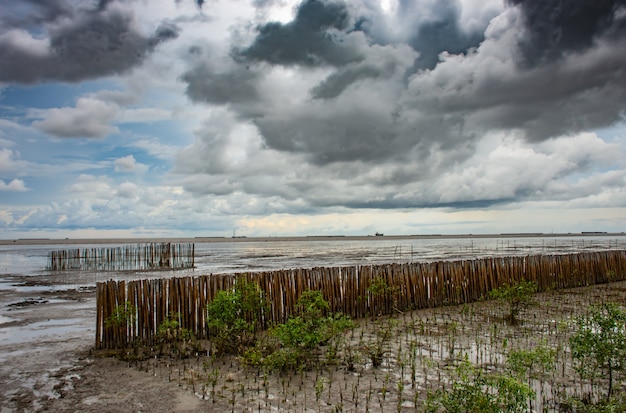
0,0,626,239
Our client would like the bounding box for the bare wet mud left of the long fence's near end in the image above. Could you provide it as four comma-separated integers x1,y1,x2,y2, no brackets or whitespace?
0,276,206,413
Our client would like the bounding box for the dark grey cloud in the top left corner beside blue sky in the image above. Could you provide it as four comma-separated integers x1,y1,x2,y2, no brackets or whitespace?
0,2,178,83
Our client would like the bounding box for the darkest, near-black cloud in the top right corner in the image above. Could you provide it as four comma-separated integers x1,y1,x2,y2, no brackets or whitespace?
510,0,626,66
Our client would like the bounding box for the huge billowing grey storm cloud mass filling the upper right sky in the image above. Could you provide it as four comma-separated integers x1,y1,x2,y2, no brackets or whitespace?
176,0,626,208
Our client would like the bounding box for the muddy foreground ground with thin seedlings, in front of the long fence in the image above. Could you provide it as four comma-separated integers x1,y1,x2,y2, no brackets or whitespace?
0,282,626,412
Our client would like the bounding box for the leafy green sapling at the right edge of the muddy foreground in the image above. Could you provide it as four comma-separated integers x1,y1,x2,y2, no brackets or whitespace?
570,303,626,400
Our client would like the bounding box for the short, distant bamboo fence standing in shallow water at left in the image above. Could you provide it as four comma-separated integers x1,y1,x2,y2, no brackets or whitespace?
47,242,195,271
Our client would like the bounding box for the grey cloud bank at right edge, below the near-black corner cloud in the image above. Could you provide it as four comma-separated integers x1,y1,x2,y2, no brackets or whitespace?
404,33,626,142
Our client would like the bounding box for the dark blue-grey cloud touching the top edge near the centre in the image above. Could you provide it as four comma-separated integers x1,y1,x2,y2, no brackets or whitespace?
235,0,361,66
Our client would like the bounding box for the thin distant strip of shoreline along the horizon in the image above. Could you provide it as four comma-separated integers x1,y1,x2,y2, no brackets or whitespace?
0,232,626,245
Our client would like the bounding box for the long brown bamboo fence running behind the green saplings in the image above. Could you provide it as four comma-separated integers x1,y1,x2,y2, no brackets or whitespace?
96,251,626,349
